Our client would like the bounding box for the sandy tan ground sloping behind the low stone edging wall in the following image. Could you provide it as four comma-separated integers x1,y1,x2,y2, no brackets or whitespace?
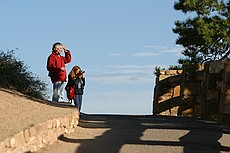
0,89,76,142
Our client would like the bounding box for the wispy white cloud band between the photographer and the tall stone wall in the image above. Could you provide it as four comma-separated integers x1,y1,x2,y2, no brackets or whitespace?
87,65,155,84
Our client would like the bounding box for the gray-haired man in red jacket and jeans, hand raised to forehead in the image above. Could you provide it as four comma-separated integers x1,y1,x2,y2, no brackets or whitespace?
47,42,71,102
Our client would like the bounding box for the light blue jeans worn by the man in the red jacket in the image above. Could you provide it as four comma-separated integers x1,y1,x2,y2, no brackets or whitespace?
52,81,65,102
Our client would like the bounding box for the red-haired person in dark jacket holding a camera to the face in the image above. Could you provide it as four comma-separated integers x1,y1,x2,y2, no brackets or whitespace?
67,66,85,112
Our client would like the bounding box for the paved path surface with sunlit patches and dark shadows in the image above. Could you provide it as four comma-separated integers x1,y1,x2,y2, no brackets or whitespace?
37,114,230,153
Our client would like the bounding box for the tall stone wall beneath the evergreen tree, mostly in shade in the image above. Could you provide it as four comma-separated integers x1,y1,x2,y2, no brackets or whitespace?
153,60,230,125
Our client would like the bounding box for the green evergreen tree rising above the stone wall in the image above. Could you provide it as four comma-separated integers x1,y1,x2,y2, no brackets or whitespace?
173,0,230,64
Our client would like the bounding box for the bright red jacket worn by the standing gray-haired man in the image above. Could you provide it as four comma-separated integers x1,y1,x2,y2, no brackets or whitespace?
47,51,72,83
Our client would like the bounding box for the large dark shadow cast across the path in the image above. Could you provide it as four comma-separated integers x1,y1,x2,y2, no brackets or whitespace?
60,115,230,153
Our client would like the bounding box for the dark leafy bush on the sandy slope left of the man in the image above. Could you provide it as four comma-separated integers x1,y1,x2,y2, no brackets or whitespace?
0,50,47,99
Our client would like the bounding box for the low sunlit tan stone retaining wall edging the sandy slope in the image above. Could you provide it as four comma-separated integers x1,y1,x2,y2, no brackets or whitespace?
0,110,79,153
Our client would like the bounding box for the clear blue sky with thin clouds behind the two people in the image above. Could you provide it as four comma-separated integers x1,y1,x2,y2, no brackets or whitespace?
0,0,186,115
